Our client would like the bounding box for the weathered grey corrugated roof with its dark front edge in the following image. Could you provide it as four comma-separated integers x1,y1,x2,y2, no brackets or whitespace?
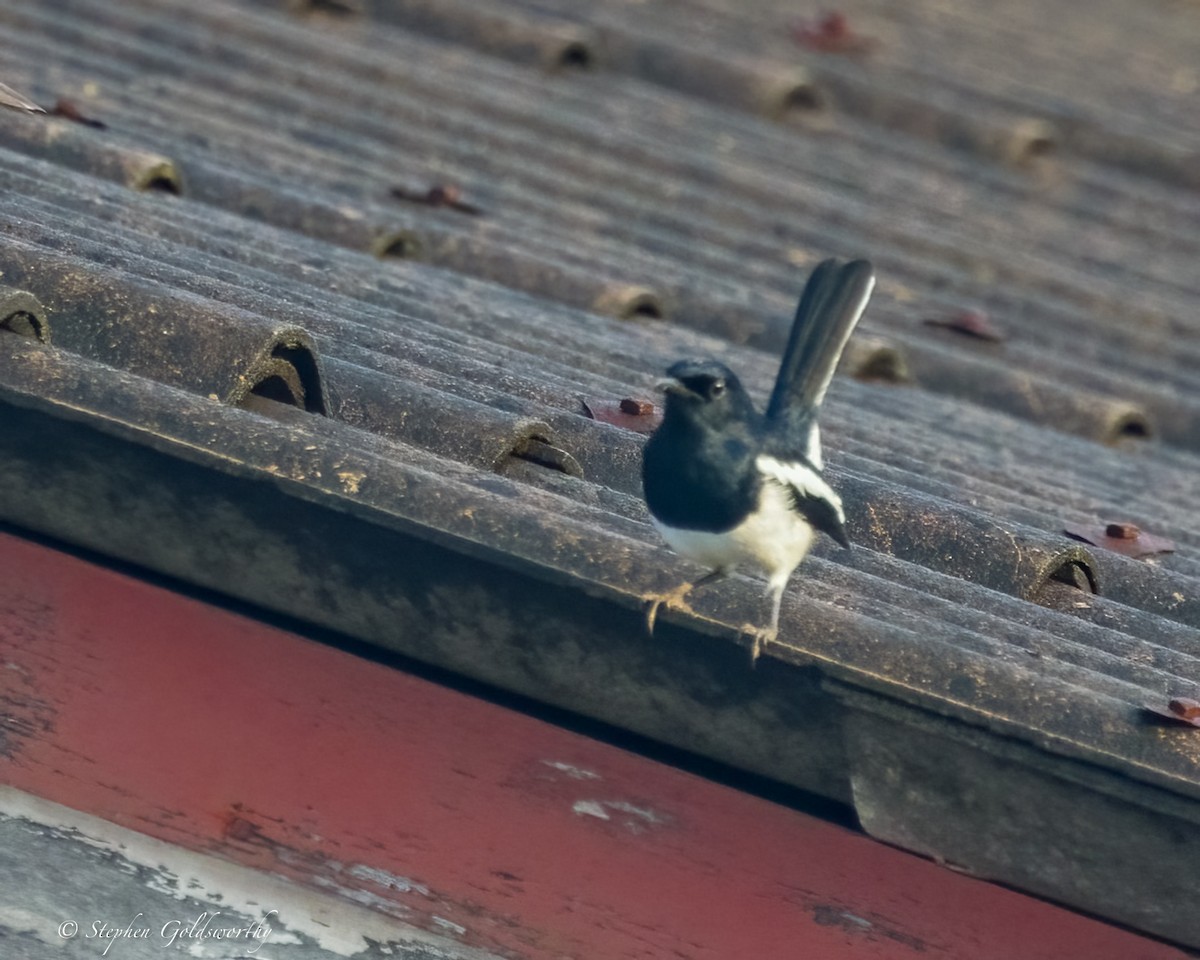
0,0,1200,944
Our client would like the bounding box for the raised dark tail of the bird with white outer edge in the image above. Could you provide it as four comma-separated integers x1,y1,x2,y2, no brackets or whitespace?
767,259,875,458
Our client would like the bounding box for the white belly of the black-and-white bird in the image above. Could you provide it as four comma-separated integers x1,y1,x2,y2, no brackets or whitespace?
650,482,814,582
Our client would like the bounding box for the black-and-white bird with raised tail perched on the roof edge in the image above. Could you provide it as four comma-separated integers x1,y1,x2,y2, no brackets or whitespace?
642,259,875,662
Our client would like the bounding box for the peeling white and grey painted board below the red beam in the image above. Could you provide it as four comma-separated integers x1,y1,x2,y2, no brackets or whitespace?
0,786,497,960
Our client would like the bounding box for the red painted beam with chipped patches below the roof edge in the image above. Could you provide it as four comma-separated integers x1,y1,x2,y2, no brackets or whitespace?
0,535,1183,960
